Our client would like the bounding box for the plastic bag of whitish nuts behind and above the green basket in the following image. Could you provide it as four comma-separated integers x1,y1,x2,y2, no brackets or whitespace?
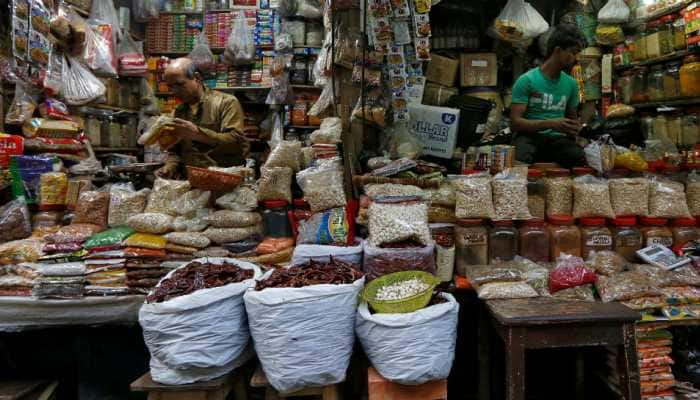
369,196,432,246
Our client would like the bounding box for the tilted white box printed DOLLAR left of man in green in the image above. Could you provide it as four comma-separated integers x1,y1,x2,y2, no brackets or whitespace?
408,104,459,159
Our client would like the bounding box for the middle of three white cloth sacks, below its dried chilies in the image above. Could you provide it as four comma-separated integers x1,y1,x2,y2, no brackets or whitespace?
243,278,365,393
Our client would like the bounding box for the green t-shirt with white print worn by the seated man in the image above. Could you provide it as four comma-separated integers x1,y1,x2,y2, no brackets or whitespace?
512,67,579,136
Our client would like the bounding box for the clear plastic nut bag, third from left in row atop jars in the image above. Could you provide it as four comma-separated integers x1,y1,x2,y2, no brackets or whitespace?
573,175,615,218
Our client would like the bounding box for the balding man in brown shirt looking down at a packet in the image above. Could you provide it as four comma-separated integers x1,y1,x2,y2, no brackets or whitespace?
156,58,250,178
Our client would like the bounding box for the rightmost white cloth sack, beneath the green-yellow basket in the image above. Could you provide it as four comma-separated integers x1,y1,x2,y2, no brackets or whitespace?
355,293,459,385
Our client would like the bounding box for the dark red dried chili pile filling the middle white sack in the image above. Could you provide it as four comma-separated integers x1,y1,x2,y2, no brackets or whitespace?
255,259,363,290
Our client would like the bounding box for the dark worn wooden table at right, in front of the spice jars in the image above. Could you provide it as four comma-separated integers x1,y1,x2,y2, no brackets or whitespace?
479,298,641,400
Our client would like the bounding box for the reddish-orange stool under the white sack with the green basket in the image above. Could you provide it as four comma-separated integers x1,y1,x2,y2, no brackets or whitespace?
367,367,447,400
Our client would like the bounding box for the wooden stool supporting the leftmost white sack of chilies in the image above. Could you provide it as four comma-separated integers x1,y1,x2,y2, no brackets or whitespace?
131,372,248,400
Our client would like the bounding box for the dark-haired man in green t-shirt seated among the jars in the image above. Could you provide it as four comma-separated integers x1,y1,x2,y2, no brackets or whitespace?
510,25,584,167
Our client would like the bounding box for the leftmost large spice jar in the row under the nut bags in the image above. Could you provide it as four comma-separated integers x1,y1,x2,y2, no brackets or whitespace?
455,219,489,276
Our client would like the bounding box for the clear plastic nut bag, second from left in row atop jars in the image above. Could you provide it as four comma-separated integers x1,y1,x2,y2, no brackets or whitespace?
491,170,532,220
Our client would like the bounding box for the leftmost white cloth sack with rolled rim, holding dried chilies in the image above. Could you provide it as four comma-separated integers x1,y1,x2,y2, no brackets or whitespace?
139,258,262,385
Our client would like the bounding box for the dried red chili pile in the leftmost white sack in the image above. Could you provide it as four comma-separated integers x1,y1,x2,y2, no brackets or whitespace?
146,262,253,303
